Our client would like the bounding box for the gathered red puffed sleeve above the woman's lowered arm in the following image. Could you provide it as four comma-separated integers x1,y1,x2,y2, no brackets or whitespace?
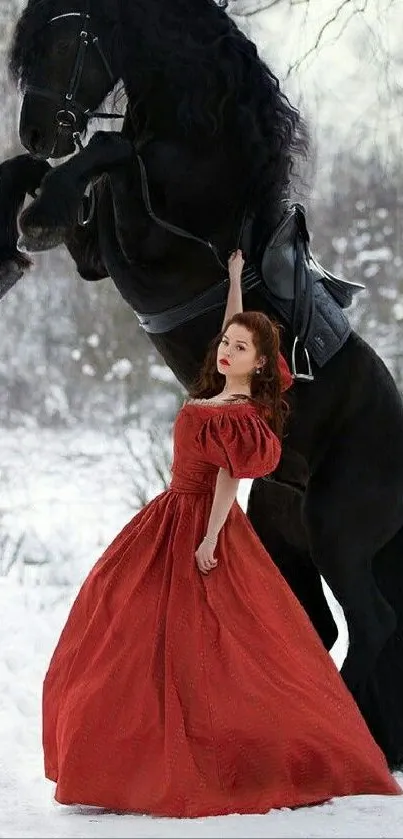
197,408,281,478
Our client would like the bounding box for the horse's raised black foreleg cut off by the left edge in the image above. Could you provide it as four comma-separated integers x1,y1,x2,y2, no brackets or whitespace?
0,154,50,298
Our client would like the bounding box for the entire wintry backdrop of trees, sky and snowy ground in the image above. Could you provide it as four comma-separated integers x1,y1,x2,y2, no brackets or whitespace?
0,0,403,837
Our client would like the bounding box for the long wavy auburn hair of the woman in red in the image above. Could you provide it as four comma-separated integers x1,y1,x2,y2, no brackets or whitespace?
189,312,289,439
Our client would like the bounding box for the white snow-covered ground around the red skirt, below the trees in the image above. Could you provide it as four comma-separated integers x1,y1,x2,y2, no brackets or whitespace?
0,429,403,839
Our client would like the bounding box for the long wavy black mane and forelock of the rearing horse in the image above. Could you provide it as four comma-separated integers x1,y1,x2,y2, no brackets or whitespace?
9,0,308,199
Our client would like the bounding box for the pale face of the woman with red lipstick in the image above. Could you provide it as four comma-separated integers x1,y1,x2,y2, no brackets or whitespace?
217,323,258,381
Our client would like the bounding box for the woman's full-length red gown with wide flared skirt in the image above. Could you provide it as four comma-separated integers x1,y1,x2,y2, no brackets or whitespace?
43,403,401,817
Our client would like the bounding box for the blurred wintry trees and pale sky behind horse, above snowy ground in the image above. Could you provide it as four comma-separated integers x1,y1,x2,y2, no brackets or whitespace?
0,0,403,428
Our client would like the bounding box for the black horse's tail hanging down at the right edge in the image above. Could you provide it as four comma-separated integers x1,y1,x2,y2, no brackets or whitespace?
358,526,403,769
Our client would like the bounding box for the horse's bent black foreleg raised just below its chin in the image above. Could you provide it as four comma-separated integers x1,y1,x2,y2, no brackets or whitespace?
19,131,133,251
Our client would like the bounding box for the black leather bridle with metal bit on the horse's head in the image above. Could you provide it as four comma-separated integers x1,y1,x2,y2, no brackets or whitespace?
25,0,124,150
